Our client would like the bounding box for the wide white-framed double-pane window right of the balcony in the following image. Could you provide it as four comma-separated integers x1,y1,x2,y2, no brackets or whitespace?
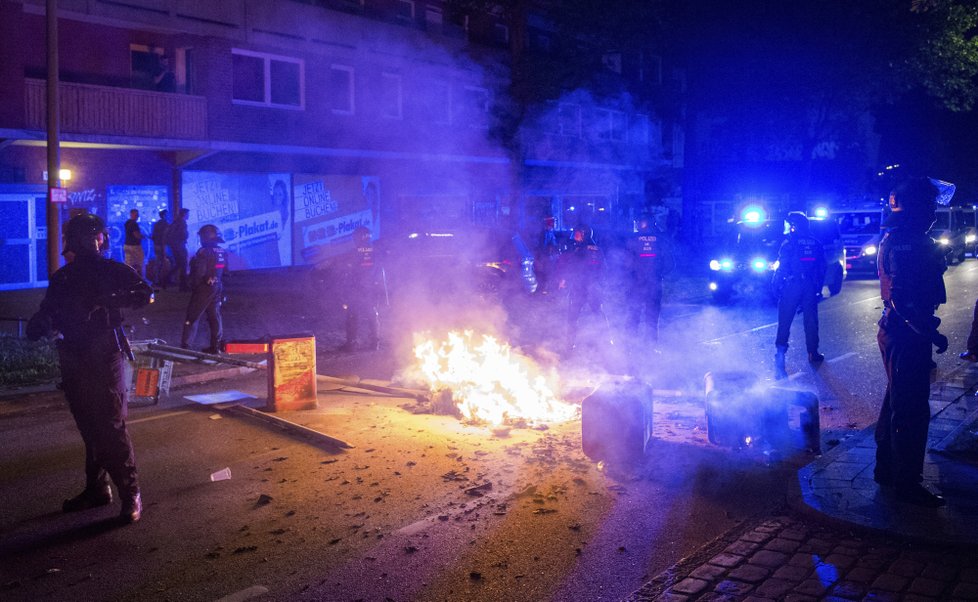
231,48,304,108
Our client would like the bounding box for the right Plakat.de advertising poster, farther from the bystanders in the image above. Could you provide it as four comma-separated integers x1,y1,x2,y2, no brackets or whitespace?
292,174,380,264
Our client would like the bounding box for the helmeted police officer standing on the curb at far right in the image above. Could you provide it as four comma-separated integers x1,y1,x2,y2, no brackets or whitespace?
873,178,948,508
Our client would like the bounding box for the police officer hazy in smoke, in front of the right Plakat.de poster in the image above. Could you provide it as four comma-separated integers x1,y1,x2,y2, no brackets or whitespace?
339,226,382,351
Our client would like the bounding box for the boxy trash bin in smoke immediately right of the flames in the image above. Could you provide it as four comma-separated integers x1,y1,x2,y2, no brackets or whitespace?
581,380,652,464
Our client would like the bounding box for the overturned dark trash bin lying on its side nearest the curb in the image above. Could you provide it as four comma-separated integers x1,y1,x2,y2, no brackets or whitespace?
705,372,821,454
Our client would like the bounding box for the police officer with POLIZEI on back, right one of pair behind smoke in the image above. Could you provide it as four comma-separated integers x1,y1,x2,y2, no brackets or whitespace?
626,214,674,345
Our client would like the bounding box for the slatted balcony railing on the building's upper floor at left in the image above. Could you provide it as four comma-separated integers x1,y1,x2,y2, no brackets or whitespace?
25,79,207,140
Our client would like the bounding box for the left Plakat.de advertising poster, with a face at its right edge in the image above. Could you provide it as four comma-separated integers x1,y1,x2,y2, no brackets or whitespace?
182,171,293,271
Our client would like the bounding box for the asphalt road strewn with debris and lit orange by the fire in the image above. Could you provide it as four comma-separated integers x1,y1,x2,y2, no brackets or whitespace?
0,261,978,601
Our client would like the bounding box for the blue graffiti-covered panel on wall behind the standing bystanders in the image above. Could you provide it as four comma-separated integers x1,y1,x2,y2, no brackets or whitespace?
107,185,170,261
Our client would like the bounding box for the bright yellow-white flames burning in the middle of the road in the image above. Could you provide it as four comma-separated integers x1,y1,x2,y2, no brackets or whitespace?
414,330,579,425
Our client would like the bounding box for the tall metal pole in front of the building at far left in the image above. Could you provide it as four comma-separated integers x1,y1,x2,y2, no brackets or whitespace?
47,0,61,278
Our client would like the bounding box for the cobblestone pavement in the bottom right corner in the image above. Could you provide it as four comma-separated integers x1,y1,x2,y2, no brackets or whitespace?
628,516,978,602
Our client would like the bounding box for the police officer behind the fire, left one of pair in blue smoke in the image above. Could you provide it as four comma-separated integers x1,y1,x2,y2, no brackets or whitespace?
557,224,607,348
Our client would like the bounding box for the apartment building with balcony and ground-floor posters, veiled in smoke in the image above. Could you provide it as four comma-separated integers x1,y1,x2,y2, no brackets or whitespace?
0,0,682,288
